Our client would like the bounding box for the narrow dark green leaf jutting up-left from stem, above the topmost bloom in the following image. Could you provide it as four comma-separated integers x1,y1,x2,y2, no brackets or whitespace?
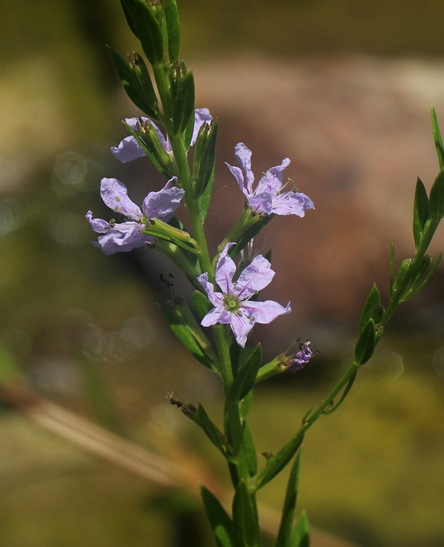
107,46,159,120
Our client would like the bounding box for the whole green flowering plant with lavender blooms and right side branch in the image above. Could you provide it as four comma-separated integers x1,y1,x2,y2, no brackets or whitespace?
86,0,444,547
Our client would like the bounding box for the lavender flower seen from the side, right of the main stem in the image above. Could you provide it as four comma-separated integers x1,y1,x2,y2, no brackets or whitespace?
226,142,314,217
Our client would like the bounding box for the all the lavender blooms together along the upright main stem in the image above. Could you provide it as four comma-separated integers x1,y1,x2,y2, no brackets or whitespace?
86,108,314,348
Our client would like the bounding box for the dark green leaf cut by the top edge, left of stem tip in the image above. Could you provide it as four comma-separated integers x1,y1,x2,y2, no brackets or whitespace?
131,0,164,65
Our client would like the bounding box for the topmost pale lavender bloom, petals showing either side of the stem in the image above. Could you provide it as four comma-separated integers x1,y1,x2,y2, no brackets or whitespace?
111,108,213,163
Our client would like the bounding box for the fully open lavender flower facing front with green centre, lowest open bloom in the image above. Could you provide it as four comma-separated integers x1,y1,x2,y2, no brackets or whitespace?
197,243,291,347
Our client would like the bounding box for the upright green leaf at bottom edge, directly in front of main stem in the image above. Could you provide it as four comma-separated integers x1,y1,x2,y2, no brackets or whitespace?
233,480,260,545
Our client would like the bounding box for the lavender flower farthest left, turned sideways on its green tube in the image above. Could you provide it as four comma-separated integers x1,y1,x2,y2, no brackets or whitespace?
86,177,185,255
